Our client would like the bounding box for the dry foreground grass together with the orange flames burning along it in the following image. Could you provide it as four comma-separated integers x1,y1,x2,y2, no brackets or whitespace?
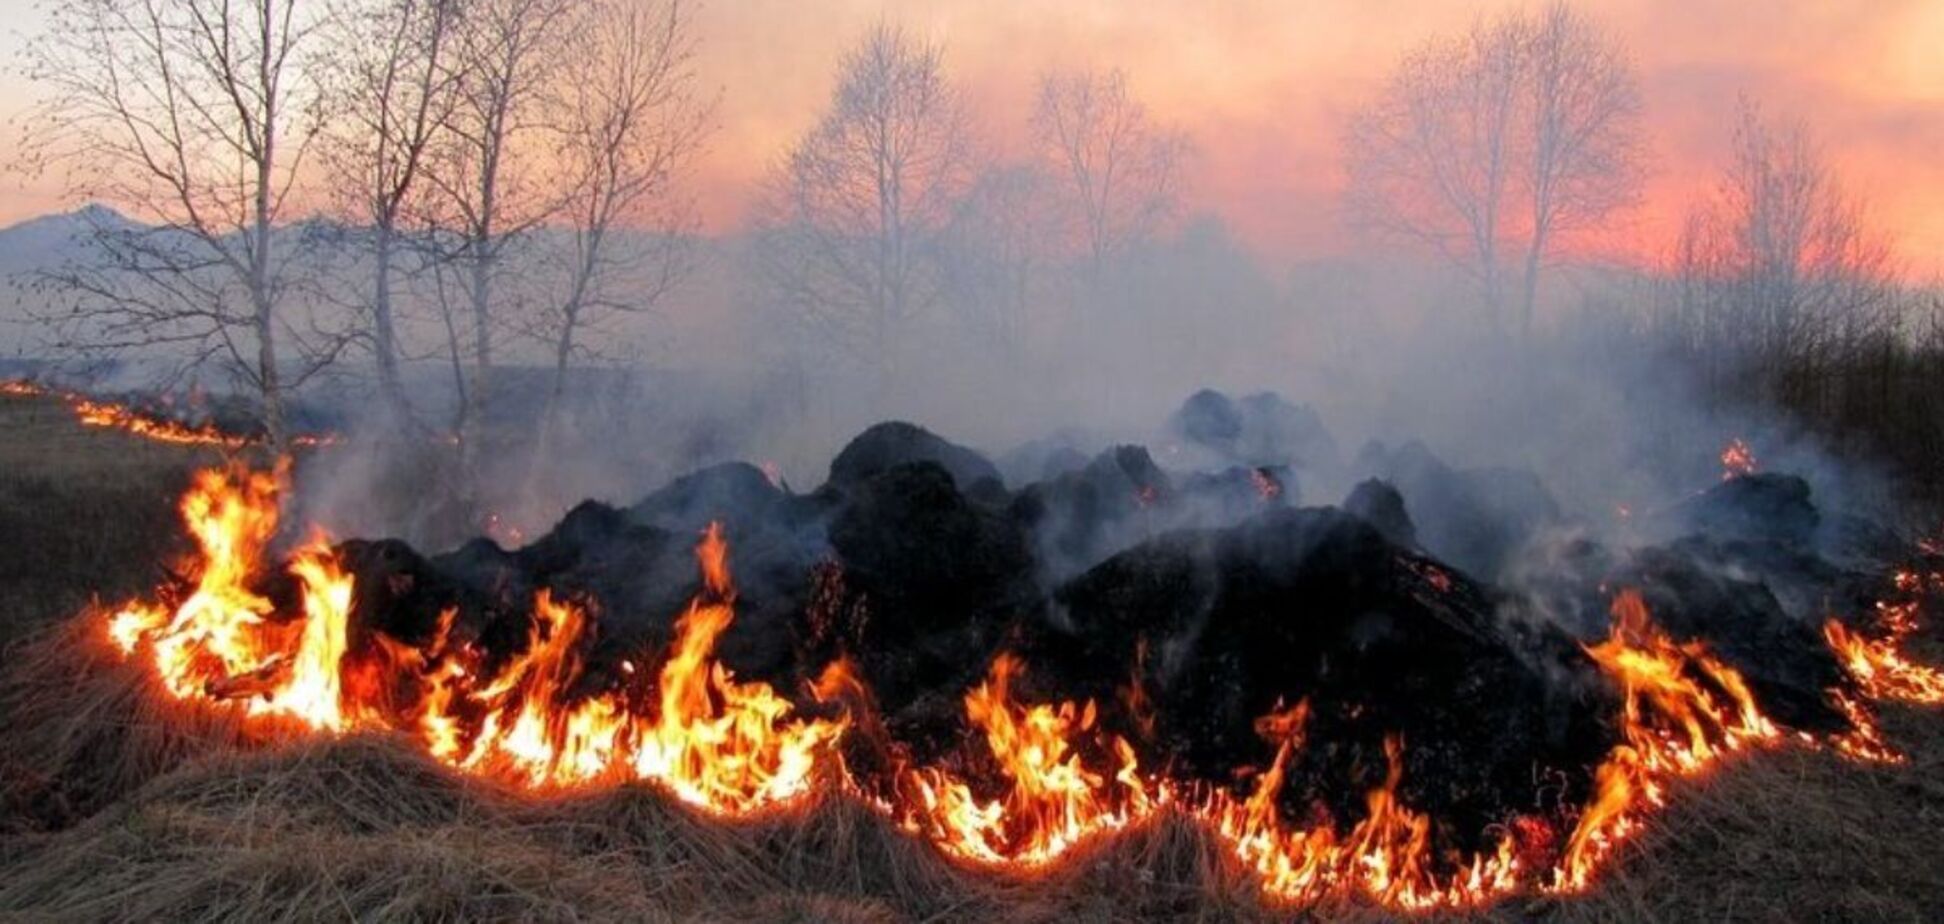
0,408,1944,920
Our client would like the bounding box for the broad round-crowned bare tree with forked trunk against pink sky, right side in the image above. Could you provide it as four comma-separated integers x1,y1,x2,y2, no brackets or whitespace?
1343,4,1641,337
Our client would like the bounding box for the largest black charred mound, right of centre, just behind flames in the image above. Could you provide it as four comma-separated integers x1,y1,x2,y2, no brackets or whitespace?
1026,508,1615,846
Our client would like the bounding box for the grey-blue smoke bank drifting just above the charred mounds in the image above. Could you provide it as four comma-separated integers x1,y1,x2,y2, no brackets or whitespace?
246,213,1892,591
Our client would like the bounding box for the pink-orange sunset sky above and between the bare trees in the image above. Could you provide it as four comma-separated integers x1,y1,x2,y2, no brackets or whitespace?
0,0,1944,278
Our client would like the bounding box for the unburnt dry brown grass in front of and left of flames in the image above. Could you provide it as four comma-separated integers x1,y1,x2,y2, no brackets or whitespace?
0,399,1944,922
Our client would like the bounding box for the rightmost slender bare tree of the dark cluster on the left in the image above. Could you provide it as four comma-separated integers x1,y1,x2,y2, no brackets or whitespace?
537,0,710,445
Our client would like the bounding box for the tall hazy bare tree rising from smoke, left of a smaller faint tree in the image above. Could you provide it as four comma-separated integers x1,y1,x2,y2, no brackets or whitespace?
756,25,970,375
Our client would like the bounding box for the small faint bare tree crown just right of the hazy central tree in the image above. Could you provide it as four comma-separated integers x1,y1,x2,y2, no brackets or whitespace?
1032,70,1188,278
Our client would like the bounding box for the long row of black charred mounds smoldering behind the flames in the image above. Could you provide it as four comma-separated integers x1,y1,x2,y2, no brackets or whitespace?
311,393,1897,850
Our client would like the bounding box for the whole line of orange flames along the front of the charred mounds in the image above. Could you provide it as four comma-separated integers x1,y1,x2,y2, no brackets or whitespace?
87,469,1944,908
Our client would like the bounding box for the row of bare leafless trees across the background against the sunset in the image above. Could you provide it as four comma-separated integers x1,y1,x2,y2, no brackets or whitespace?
11,0,1934,505
